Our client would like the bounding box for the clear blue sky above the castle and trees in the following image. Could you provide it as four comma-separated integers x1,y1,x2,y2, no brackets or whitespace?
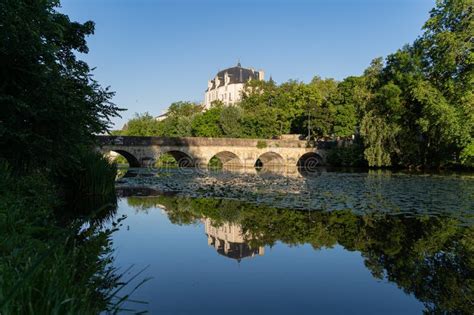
59,0,434,128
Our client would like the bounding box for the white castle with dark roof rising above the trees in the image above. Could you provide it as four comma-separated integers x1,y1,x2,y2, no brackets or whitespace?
204,62,265,109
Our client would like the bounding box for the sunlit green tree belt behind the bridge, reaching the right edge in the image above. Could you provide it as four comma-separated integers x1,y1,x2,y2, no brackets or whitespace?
116,0,474,168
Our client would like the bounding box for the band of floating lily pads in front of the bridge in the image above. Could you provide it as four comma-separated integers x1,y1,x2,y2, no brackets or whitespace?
117,168,474,225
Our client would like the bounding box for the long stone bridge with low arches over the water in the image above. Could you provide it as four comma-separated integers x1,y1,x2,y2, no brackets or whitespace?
98,136,328,167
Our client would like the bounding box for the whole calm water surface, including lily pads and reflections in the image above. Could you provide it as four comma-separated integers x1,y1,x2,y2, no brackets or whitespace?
114,171,474,314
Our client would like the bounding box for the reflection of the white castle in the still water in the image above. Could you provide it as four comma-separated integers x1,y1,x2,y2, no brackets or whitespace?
203,218,265,261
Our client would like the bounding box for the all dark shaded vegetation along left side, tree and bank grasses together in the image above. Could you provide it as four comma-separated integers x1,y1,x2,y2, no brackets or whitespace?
0,0,144,314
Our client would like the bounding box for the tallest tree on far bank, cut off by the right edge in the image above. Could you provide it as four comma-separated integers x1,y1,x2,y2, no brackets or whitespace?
415,0,474,167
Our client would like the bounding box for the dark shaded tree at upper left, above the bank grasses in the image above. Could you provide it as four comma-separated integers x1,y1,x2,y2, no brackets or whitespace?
0,0,119,171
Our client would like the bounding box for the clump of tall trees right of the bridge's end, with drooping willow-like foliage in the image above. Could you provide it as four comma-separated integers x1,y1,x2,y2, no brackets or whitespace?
354,0,474,167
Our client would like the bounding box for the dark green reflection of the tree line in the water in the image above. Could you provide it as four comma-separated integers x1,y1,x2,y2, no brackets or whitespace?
128,196,474,313
